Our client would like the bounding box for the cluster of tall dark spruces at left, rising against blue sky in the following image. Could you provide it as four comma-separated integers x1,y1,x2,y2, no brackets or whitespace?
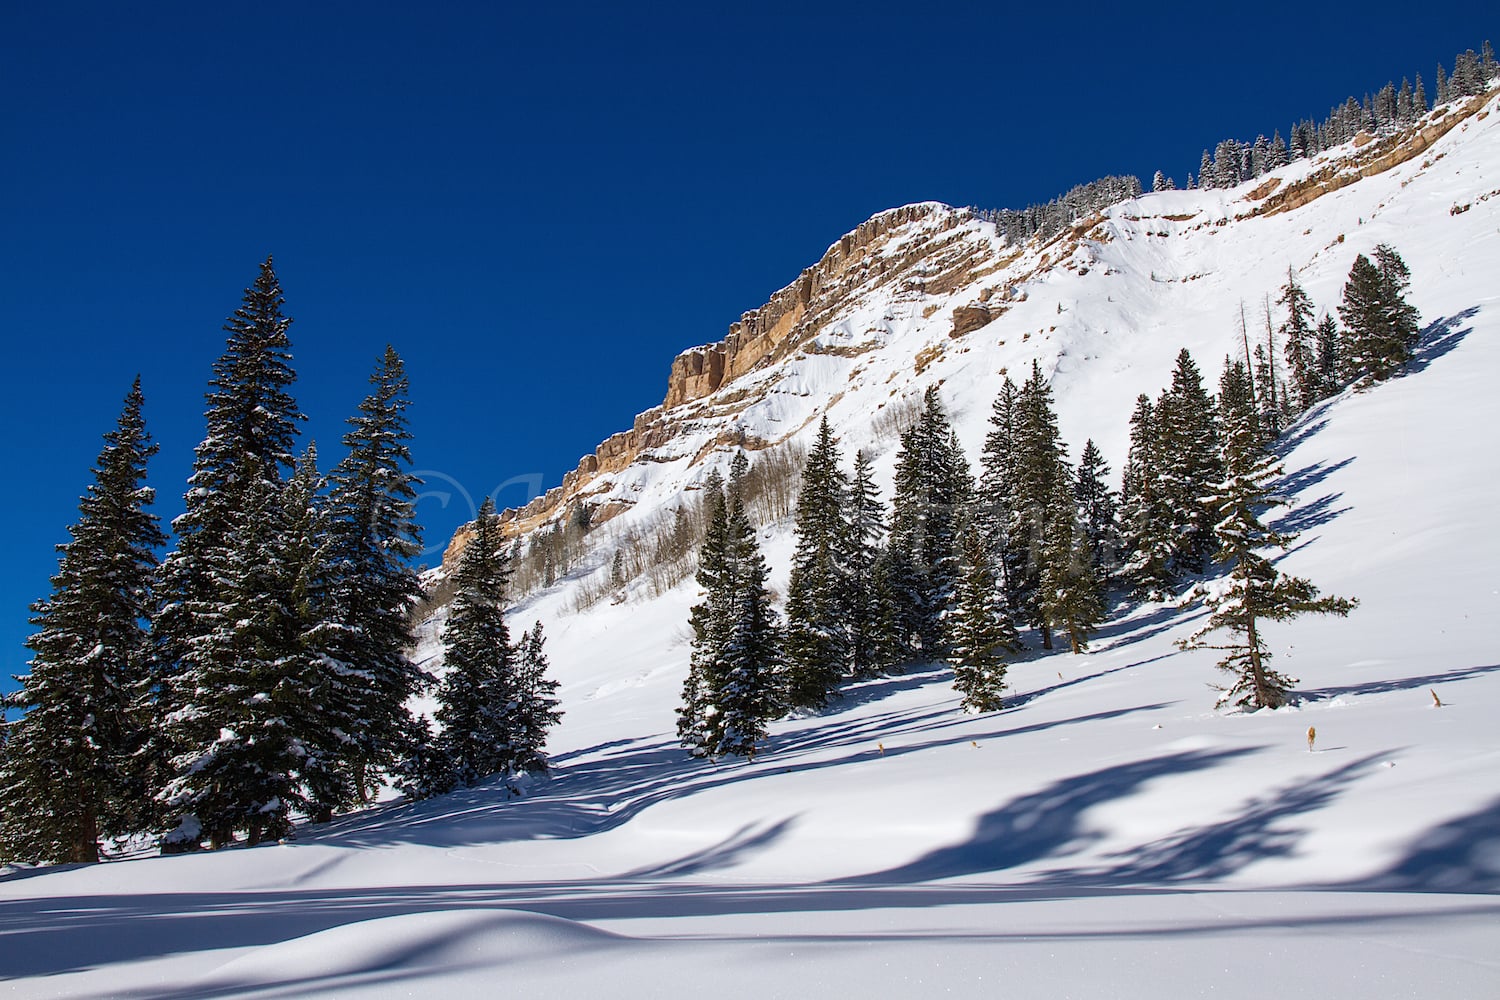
0,258,560,862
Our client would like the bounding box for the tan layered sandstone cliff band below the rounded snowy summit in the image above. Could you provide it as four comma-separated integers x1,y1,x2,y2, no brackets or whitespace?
443,202,1001,567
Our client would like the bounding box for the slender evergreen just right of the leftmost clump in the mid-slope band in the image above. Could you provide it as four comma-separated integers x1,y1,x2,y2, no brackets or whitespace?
786,417,851,709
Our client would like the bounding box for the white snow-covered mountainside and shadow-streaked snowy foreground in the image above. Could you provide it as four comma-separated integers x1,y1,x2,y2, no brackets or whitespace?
0,94,1500,999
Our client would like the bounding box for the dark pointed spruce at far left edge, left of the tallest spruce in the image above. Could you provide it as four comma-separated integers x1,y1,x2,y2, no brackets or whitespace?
0,378,167,862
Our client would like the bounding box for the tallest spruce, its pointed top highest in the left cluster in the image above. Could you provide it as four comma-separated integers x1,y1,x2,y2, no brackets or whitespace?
146,258,302,846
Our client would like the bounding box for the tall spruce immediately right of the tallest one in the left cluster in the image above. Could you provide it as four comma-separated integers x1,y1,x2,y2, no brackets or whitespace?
318,346,431,816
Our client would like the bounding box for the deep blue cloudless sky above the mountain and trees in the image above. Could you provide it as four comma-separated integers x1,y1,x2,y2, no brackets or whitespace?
0,0,1490,687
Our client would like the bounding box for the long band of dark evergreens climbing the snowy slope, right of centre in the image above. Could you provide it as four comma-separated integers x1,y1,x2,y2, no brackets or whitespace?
678,246,1419,759
